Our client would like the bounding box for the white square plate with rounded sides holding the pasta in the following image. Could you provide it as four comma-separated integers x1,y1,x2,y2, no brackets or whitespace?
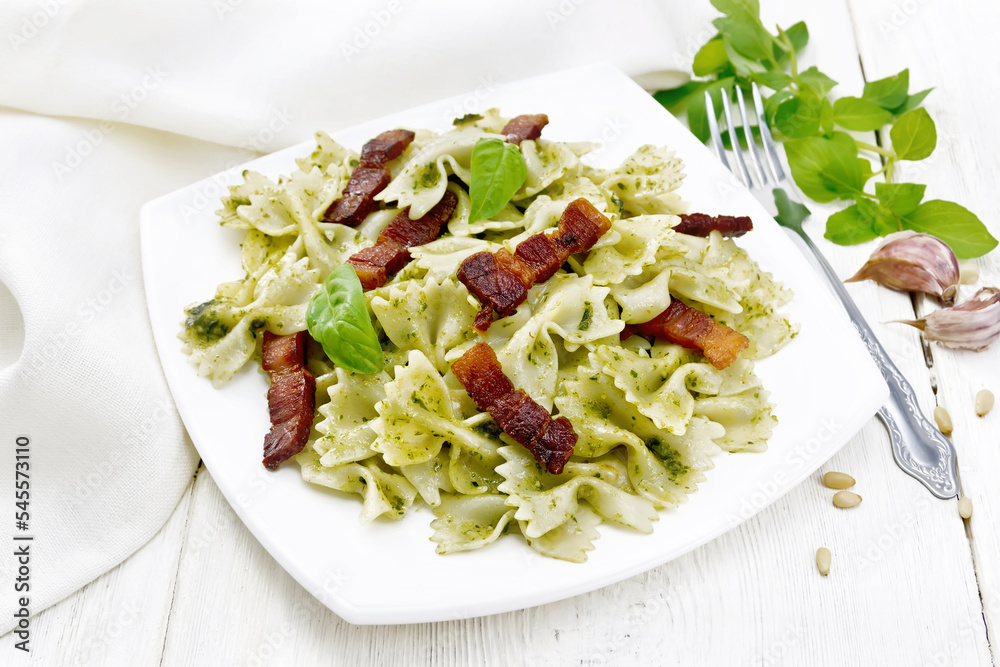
142,65,888,623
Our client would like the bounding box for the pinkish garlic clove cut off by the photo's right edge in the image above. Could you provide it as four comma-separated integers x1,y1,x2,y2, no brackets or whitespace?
898,287,1000,350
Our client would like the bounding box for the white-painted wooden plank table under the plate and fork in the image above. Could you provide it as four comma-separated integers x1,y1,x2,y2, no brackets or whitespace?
0,0,1000,667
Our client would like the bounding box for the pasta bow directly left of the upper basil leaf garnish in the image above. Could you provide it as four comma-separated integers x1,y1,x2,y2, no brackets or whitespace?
375,127,503,220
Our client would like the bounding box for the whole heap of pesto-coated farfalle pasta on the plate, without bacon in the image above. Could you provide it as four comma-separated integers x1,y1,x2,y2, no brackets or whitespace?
180,110,796,562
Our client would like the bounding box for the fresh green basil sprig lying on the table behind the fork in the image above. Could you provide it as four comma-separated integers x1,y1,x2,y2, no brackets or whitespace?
654,0,997,258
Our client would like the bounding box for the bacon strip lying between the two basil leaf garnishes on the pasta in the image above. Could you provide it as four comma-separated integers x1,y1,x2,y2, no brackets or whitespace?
347,191,458,289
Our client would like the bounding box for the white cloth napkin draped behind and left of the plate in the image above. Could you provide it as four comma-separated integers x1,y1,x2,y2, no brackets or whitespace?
0,0,707,632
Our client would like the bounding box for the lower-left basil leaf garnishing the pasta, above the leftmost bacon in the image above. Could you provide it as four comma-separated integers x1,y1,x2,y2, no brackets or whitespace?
306,264,382,375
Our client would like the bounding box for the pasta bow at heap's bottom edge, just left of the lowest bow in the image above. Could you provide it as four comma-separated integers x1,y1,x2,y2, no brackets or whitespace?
431,493,514,554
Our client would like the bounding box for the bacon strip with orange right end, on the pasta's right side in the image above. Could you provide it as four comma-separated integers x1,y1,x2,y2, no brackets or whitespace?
621,299,750,370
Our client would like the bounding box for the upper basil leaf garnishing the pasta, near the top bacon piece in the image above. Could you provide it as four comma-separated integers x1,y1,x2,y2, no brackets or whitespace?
469,139,528,222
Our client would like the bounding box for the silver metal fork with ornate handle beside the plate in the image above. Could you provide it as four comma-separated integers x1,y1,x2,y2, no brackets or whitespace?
705,83,958,498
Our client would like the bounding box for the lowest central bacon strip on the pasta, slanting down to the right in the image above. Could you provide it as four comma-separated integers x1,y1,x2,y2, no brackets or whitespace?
451,343,576,475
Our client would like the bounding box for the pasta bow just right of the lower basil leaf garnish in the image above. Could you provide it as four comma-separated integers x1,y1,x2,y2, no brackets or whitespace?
371,279,478,373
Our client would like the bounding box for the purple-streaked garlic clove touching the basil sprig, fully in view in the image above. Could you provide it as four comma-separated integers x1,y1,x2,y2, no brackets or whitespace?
845,230,960,303
